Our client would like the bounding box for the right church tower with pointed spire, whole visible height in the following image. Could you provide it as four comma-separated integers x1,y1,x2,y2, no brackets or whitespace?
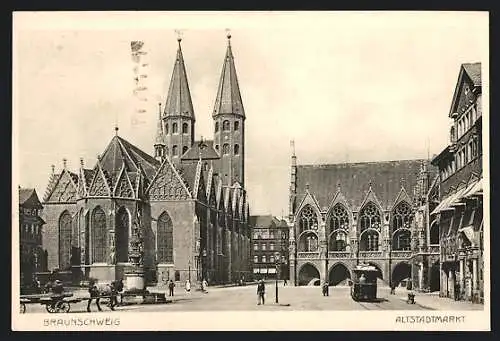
212,34,245,187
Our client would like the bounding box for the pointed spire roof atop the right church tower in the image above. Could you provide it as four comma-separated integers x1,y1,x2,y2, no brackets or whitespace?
213,35,245,117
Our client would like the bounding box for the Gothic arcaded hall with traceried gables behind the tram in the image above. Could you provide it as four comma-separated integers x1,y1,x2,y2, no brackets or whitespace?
289,143,435,286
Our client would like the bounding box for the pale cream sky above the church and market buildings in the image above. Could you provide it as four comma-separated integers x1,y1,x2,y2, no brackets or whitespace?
13,12,489,216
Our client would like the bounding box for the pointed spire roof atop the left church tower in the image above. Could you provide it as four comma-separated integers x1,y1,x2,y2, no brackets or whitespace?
163,39,195,119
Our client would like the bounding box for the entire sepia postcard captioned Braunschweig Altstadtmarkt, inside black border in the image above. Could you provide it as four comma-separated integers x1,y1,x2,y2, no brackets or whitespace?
12,12,490,330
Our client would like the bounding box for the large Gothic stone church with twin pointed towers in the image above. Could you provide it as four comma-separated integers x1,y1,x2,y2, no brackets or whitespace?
38,36,250,284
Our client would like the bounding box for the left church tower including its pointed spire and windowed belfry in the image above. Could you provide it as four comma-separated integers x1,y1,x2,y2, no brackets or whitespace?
163,38,195,164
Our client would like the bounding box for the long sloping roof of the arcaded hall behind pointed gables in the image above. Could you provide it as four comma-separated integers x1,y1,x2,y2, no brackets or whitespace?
297,159,433,210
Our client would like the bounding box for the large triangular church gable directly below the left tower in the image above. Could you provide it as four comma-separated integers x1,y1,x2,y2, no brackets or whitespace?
147,157,192,200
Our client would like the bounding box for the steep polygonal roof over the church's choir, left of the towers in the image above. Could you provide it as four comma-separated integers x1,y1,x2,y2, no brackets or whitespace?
100,136,160,183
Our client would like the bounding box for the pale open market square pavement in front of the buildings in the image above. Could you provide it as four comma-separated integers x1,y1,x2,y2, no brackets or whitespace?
20,283,483,313
